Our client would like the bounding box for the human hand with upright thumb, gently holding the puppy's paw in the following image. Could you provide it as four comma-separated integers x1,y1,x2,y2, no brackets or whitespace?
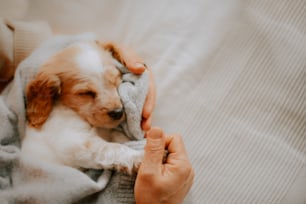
134,128,194,204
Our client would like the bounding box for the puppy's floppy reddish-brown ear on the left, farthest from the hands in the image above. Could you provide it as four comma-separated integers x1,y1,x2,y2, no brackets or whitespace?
26,73,61,128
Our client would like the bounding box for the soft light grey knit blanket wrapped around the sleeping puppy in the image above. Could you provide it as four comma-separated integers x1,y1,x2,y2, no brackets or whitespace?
0,33,148,203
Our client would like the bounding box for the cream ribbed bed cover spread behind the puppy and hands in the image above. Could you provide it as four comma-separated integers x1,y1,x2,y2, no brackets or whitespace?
0,0,306,204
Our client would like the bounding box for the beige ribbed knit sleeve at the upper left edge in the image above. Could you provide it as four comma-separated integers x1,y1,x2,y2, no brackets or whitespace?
0,18,52,92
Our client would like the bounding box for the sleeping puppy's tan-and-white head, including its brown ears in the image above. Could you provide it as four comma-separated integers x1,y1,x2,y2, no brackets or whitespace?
26,42,125,128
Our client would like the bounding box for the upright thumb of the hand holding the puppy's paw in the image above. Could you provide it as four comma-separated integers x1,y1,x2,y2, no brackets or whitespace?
142,128,166,172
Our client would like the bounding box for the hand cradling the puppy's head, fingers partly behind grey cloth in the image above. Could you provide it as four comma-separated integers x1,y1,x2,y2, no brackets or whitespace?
118,46,156,131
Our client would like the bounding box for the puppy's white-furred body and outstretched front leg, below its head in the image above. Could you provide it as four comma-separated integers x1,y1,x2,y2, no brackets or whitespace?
22,104,142,173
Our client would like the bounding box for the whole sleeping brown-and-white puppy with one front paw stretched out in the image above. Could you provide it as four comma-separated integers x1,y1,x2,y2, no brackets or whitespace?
22,42,143,173
